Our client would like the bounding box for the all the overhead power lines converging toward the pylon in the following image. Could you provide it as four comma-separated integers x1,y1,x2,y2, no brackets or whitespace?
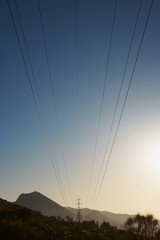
6,0,154,214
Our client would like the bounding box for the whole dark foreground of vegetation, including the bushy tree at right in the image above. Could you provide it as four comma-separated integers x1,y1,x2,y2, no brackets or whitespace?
0,206,160,240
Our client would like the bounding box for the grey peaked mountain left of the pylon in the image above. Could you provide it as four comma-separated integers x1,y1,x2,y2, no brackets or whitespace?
15,192,73,218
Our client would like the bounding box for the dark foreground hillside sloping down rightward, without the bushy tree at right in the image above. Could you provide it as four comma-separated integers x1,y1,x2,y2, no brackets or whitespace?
0,199,135,240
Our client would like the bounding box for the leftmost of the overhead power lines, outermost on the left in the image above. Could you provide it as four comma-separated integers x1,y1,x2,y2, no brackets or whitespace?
7,0,66,206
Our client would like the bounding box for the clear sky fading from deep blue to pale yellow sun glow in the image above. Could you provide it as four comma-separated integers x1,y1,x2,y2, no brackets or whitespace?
0,0,160,219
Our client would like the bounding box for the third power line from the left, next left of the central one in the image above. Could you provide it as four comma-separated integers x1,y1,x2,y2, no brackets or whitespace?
37,0,73,206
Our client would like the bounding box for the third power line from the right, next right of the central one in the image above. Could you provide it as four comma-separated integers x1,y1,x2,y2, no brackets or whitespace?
86,0,117,204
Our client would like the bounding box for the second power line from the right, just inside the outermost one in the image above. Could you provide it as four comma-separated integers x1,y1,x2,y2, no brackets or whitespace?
92,0,142,207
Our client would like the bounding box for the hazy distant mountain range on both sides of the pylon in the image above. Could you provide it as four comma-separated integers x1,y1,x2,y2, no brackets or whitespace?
15,192,132,228
